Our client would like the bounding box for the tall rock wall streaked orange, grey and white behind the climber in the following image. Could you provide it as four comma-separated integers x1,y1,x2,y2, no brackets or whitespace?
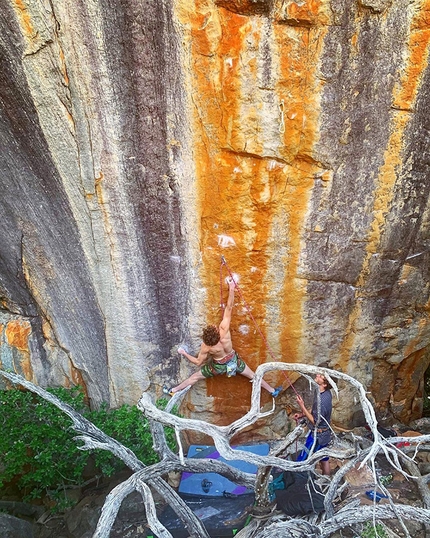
0,0,430,423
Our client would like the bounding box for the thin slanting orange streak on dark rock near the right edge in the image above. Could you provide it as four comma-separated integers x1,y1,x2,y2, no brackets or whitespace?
338,0,430,371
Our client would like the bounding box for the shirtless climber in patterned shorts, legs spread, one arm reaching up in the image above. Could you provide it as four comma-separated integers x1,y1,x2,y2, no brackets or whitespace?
163,279,282,398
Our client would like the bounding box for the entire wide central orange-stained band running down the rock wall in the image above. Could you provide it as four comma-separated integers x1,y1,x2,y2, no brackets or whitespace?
175,0,328,412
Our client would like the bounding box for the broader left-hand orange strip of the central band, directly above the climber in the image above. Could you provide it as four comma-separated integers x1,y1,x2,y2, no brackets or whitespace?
181,5,276,406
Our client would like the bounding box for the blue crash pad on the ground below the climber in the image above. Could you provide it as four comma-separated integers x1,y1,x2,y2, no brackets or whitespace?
178,443,269,497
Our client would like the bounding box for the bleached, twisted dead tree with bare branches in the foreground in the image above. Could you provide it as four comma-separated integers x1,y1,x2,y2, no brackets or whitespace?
0,363,430,538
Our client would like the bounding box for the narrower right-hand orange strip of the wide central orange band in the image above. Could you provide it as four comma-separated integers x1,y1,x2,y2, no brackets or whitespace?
275,21,327,364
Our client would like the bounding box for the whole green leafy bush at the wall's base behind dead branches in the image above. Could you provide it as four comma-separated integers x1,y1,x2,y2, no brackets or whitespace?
0,387,175,507
